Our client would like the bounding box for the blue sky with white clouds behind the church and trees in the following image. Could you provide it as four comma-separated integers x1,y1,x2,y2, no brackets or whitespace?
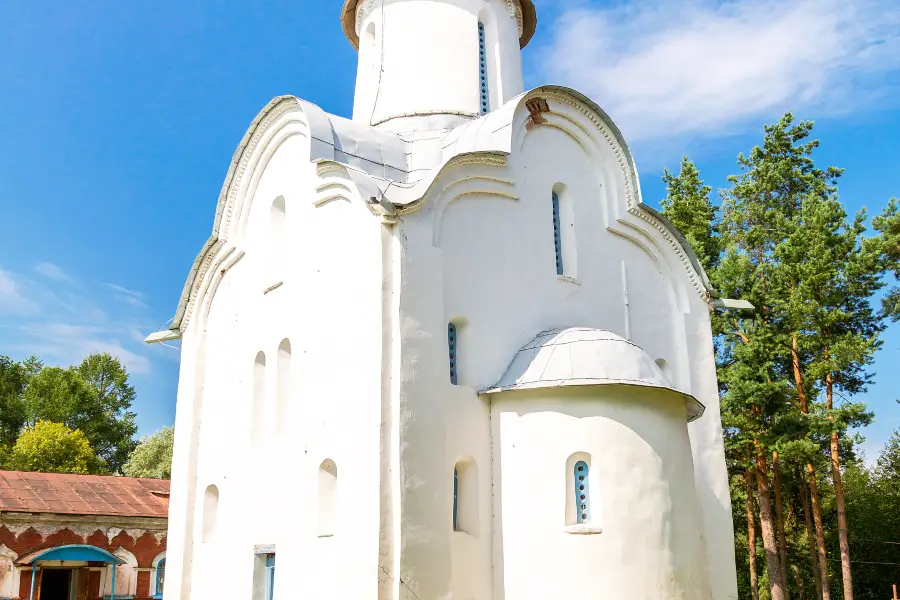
0,0,900,454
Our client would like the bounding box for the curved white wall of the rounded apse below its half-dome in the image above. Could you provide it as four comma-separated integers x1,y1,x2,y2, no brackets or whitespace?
491,386,711,600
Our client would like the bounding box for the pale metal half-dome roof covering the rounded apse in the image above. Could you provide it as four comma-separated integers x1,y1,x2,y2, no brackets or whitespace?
482,327,704,421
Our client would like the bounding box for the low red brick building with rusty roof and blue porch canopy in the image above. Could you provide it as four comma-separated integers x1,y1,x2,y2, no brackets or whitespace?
0,471,169,600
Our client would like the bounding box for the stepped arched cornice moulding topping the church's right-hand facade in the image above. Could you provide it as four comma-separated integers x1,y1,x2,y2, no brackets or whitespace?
386,86,714,300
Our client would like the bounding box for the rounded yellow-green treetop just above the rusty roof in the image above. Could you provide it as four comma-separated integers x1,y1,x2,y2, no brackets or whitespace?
4,421,103,473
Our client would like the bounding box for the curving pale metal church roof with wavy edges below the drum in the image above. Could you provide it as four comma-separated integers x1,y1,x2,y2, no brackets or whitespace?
146,85,718,343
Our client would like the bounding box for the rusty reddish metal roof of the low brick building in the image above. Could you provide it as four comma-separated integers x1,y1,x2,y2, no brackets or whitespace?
0,471,169,517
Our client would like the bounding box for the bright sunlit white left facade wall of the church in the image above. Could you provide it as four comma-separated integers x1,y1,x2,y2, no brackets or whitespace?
165,110,382,600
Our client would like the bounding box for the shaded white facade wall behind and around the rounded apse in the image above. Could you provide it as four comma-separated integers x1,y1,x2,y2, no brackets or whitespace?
396,96,735,600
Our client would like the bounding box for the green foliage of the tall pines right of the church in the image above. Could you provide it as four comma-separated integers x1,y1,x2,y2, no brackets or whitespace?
663,113,900,600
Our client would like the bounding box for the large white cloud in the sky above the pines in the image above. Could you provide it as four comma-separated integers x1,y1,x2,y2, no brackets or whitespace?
542,0,900,141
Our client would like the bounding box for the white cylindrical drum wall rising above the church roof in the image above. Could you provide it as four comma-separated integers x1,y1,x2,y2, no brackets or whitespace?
353,0,524,132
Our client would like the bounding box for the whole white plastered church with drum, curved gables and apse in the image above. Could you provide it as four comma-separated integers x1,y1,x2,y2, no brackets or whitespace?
148,0,737,600
